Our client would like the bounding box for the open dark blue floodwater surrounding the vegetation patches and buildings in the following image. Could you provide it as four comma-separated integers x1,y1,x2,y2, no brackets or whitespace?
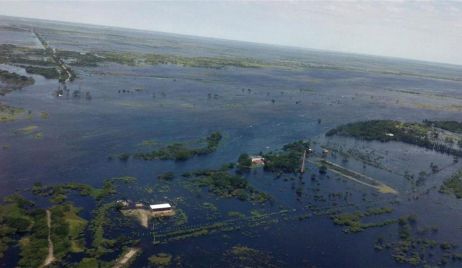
0,15,462,267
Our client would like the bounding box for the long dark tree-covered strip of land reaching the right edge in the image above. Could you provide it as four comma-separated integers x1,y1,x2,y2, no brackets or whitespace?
326,120,462,156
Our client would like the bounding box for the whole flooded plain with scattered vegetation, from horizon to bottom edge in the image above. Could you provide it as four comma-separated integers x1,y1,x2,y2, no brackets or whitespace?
0,17,462,267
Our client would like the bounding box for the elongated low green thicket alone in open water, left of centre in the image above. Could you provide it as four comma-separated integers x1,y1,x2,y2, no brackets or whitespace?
133,132,222,161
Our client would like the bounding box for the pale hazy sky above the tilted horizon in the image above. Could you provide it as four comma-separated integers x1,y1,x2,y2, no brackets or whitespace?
0,0,462,65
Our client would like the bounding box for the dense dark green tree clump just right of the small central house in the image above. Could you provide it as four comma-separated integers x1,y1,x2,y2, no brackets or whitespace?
263,141,310,173
